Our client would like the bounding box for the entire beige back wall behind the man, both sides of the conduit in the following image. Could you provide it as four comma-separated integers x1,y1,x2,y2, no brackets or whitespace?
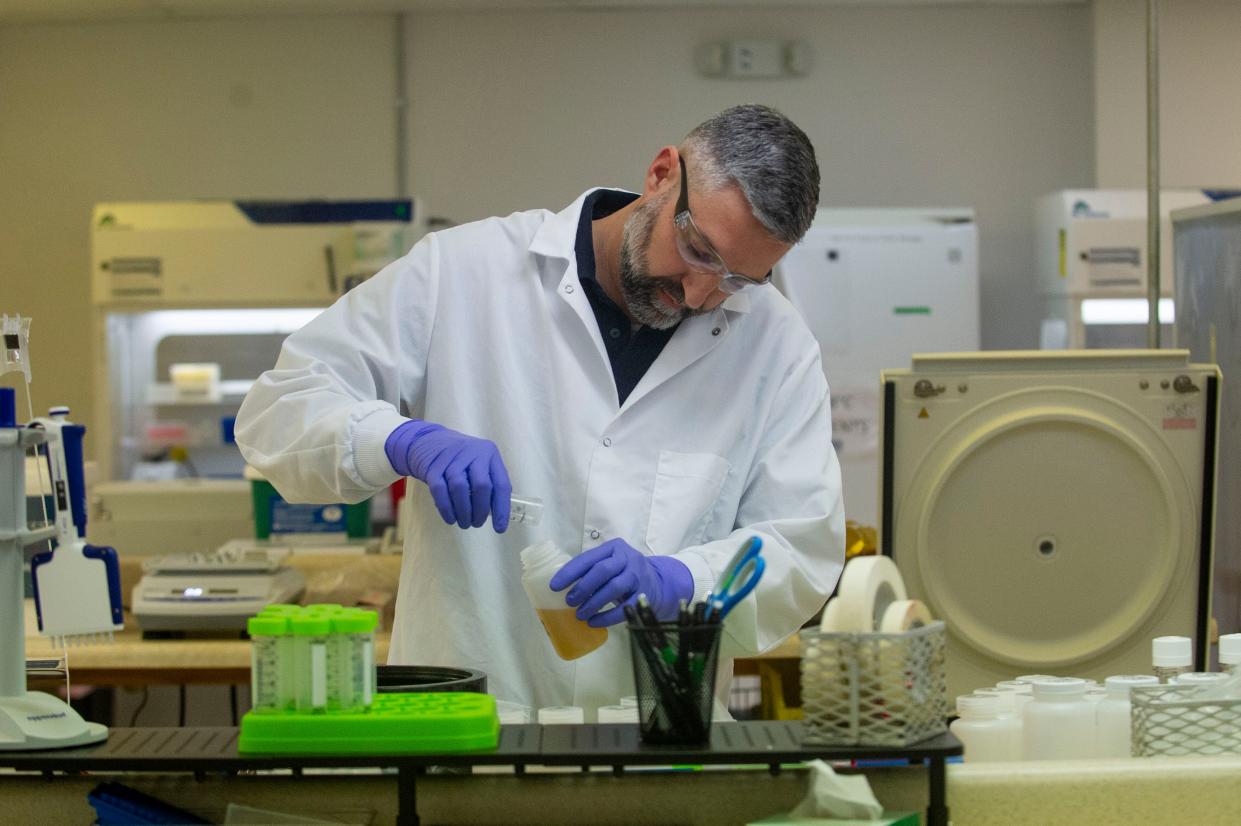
0,5,1095,458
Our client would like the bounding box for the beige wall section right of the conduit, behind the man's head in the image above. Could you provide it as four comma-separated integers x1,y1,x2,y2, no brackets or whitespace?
410,6,1095,349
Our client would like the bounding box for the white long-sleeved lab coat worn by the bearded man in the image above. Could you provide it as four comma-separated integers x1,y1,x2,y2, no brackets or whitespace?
236,186,844,719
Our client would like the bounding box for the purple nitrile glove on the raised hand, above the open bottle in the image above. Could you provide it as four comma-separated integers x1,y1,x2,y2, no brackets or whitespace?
383,419,513,533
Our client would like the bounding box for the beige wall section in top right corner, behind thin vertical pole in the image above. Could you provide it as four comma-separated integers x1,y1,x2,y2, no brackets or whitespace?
1093,0,1241,187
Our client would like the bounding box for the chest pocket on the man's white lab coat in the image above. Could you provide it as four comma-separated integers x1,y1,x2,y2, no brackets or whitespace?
647,450,732,553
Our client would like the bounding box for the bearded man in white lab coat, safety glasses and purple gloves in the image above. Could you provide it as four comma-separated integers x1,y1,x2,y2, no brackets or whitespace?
236,105,844,719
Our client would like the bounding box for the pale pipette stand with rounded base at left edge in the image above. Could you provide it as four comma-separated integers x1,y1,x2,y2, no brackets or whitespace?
0,422,108,750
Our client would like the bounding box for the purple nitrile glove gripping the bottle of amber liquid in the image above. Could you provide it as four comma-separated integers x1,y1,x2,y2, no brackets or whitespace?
549,540,694,628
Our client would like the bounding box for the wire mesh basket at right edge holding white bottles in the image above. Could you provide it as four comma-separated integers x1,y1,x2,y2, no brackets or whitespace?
1129,686,1241,757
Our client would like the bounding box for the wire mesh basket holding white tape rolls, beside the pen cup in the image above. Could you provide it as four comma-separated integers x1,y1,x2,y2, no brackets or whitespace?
802,621,948,747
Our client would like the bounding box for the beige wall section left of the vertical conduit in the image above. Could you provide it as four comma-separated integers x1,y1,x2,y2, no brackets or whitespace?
0,16,396,436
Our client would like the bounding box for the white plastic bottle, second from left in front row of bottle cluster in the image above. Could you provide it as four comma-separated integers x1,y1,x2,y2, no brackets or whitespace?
1021,677,1095,760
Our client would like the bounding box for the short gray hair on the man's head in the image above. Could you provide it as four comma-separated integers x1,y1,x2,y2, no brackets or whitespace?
680,103,819,244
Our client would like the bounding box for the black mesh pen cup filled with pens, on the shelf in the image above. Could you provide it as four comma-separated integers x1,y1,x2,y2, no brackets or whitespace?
629,623,724,744
